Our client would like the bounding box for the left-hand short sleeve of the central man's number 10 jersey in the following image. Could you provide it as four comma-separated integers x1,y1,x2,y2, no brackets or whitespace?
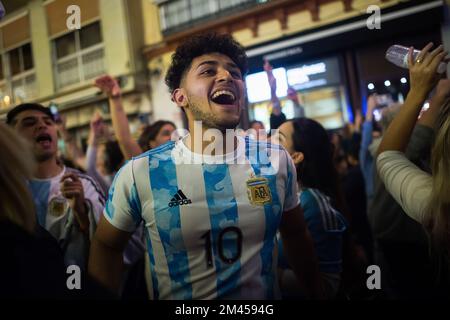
104,161,142,232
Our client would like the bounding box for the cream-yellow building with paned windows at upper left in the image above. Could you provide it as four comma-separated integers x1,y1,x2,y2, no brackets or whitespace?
0,0,152,148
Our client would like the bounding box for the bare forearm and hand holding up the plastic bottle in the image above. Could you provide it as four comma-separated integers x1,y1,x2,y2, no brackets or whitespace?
378,43,447,154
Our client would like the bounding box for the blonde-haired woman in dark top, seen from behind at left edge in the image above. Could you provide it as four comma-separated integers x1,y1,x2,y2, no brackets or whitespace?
0,123,66,298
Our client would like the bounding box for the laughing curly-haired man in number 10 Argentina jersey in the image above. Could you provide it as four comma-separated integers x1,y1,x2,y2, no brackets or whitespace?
89,34,321,299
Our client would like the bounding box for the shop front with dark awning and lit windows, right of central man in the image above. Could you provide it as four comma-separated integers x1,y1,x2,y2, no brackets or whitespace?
244,1,444,130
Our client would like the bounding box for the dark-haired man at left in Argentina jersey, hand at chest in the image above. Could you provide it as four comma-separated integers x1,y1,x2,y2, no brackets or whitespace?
7,104,105,269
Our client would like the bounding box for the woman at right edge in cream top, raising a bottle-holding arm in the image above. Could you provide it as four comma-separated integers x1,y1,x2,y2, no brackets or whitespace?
377,43,450,290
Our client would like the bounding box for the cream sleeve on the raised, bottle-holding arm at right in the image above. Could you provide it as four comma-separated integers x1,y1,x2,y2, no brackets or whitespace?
377,151,432,223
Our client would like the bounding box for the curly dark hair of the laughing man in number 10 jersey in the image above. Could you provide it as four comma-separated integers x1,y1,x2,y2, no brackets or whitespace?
165,33,247,93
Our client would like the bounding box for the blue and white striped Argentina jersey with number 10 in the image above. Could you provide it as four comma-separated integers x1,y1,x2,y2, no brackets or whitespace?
104,137,299,299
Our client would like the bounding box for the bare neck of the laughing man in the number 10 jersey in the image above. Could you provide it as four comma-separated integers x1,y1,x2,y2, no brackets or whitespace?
186,122,238,156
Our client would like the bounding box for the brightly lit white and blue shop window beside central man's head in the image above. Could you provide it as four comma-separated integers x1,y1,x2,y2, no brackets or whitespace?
246,56,348,129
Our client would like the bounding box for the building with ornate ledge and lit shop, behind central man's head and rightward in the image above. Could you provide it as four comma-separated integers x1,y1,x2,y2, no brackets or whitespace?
144,0,445,129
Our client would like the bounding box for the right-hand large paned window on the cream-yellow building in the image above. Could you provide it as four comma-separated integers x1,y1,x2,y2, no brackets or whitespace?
53,22,105,88
